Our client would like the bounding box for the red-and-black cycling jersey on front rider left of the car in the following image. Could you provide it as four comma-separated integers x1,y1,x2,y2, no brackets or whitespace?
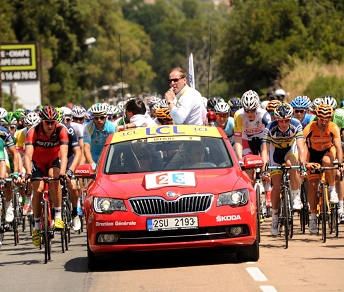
26,124,68,165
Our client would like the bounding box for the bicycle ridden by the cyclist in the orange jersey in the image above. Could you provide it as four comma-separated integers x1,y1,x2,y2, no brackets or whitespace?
317,162,343,243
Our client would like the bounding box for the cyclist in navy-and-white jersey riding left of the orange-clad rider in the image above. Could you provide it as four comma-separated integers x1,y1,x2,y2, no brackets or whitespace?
262,102,306,236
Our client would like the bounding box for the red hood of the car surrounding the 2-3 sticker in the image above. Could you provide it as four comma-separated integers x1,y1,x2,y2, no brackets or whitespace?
91,168,252,199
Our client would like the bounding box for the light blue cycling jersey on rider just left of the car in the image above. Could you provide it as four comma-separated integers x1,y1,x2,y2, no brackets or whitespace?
84,120,116,161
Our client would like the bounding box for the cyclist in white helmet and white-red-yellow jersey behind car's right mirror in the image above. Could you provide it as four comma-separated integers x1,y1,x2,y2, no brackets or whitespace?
234,90,271,179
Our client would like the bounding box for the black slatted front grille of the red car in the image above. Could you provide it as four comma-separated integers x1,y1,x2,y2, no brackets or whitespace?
129,194,214,215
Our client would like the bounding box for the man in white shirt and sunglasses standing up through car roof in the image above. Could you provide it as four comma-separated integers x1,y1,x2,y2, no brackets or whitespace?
165,68,207,125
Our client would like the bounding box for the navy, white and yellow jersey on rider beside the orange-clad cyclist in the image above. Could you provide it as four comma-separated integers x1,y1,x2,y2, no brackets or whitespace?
263,118,303,149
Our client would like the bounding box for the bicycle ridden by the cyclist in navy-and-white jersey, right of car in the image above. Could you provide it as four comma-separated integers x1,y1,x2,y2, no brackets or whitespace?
267,164,301,248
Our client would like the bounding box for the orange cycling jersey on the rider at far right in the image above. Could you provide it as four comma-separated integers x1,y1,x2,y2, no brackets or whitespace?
303,122,340,151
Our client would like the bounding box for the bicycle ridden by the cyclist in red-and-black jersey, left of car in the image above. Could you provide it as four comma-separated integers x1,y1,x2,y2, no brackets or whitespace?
31,177,60,264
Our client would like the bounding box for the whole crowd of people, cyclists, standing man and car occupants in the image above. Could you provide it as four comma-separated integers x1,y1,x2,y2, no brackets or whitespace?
0,68,344,246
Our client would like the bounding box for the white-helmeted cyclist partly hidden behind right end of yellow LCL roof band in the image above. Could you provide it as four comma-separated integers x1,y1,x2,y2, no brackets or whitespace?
214,101,234,145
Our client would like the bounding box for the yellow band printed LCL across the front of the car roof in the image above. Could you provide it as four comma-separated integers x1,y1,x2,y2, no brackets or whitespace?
109,125,222,144
